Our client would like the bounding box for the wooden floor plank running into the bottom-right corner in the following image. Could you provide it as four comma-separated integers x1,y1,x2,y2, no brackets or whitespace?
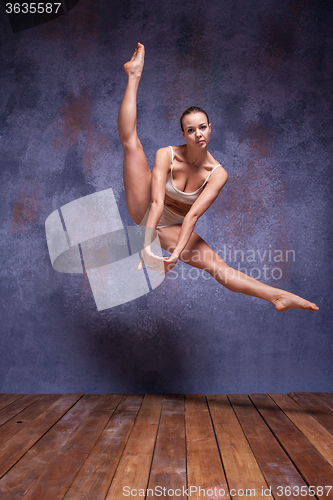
249,394,333,499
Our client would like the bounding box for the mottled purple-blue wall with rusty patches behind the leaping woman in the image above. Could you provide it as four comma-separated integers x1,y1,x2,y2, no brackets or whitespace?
0,0,333,393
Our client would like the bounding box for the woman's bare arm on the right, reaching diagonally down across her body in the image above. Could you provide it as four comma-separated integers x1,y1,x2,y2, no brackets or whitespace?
165,167,228,270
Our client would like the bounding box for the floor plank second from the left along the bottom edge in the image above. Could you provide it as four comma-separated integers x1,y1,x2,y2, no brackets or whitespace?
23,394,122,500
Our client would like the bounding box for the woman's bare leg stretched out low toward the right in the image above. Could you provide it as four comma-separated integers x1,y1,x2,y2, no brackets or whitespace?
158,226,319,311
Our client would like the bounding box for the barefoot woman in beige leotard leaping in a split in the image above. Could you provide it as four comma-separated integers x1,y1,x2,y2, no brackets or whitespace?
118,43,319,311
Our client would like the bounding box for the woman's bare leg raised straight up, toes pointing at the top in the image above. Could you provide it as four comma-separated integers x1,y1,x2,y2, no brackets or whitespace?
118,43,151,224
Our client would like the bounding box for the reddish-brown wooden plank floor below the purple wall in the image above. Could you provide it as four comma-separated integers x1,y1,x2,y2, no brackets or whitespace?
0,393,333,500
